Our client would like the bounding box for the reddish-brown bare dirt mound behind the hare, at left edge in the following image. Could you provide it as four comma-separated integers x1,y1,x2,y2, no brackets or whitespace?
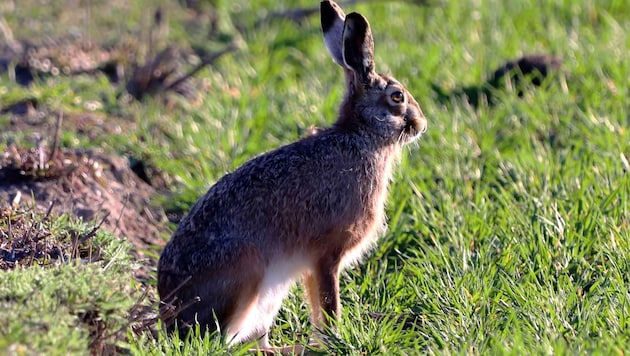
0,146,169,268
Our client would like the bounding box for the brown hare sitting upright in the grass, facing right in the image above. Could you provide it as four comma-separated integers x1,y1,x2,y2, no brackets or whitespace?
157,1,427,349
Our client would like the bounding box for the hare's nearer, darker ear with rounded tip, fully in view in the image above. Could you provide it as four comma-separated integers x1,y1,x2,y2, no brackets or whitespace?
343,12,375,84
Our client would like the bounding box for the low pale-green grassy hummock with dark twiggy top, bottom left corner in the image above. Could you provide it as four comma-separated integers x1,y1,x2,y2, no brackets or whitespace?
0,209,142,355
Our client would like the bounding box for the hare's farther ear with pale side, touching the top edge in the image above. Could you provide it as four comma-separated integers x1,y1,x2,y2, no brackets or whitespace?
320,0,346,67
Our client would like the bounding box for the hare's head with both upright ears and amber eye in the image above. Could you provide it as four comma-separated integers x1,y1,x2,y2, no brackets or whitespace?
321,1,427,144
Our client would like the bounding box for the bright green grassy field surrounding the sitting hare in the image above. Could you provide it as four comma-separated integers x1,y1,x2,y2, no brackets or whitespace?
0,0,630,355
